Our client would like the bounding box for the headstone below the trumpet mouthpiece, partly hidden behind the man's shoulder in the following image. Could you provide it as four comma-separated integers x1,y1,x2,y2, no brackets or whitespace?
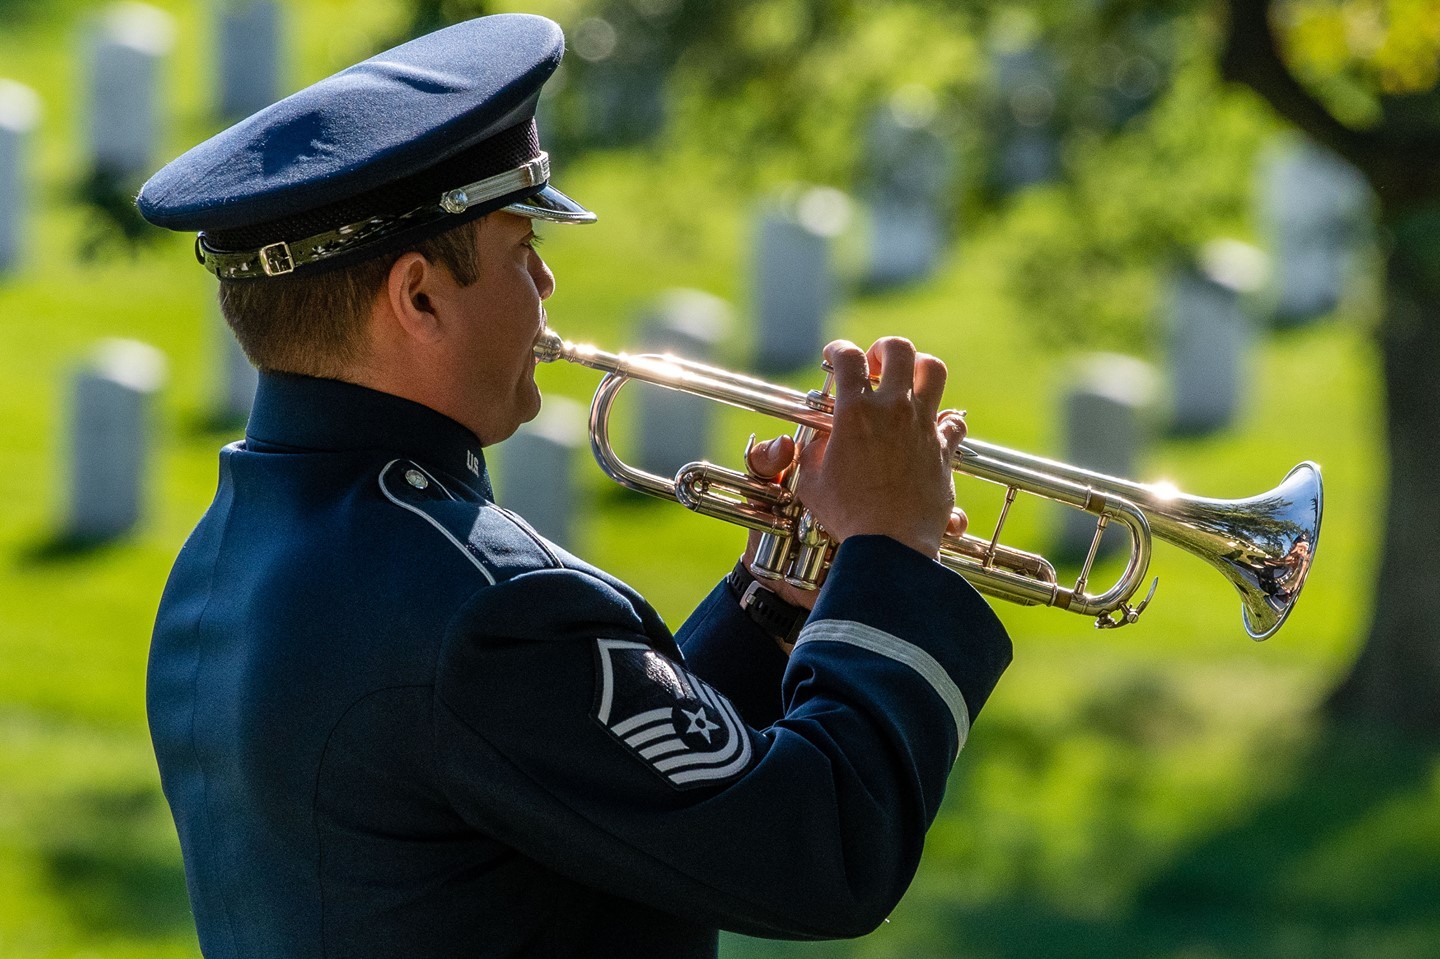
495,396,588,549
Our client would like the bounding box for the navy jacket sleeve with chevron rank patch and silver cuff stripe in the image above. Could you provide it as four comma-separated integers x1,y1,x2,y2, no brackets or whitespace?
435,537,1009,937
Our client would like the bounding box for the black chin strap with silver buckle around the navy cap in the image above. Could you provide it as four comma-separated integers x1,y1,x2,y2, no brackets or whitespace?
194,153,595,279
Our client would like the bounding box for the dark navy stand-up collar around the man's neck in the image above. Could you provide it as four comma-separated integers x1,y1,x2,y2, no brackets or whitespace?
245,373,495,501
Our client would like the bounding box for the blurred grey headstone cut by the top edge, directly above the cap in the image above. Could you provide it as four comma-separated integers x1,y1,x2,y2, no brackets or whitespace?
213,0,284,120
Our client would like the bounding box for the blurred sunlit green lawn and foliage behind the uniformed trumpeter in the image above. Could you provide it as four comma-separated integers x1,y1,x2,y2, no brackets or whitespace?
0,0,1440,959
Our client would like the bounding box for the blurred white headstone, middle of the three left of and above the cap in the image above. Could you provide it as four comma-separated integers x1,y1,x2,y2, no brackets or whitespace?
86,3,176,181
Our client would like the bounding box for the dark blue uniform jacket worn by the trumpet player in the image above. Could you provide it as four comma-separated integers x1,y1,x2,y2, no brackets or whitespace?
148,367,1009,959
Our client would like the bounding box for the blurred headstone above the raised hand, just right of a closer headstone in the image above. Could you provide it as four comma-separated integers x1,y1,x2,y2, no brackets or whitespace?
865,86,953,287
